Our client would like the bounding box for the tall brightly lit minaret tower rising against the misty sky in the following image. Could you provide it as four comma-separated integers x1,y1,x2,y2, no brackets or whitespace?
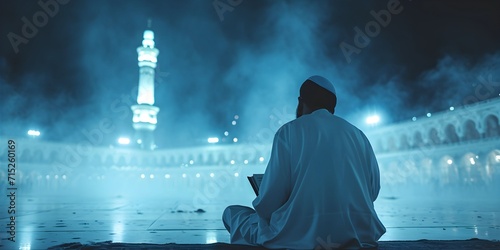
132,24,160,150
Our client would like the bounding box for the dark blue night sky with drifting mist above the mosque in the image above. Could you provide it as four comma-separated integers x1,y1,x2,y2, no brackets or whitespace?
0,0,500,148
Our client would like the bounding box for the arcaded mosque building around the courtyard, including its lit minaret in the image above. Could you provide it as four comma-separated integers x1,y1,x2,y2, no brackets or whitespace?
0,27,500,191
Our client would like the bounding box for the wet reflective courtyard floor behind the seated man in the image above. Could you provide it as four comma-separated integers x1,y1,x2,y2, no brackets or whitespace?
0,170,500,249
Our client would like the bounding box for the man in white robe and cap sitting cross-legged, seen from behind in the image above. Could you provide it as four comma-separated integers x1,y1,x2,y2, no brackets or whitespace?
222,76,385,249
